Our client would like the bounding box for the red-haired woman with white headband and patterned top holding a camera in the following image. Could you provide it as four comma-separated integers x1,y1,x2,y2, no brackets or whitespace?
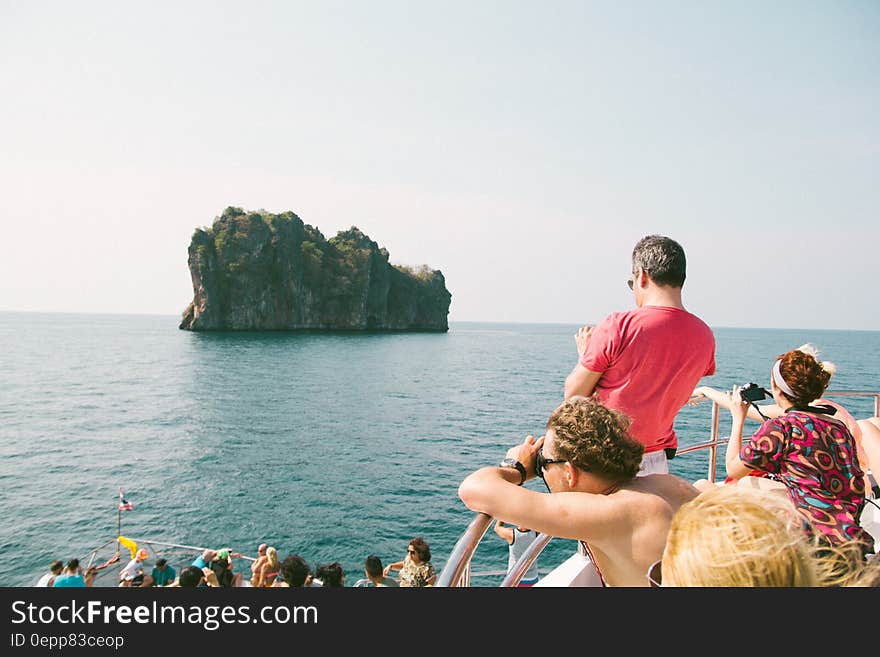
725,345,874,554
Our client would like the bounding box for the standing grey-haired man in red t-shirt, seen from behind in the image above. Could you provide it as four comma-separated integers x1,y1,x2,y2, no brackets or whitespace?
565,235,715,475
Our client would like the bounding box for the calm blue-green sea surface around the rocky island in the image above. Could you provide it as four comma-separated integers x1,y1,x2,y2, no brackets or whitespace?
0,313,880,586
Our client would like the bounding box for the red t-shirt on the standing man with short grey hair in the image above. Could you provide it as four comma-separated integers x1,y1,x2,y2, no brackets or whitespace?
580,306,715,453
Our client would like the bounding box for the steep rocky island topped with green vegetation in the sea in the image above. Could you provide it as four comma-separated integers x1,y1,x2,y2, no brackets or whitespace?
180,207,452,331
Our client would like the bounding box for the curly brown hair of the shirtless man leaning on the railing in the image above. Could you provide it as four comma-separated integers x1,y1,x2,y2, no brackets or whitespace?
547,395,645,479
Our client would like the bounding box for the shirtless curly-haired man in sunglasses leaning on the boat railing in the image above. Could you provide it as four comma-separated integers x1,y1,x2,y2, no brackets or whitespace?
458,397,698,586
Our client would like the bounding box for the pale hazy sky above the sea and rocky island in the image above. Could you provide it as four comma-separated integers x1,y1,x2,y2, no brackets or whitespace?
0,0,880,330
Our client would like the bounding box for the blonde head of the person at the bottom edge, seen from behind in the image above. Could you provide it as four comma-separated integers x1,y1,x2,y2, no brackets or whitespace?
662,486,822,587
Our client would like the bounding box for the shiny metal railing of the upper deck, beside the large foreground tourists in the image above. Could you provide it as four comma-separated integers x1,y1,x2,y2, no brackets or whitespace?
436,390,880,587
